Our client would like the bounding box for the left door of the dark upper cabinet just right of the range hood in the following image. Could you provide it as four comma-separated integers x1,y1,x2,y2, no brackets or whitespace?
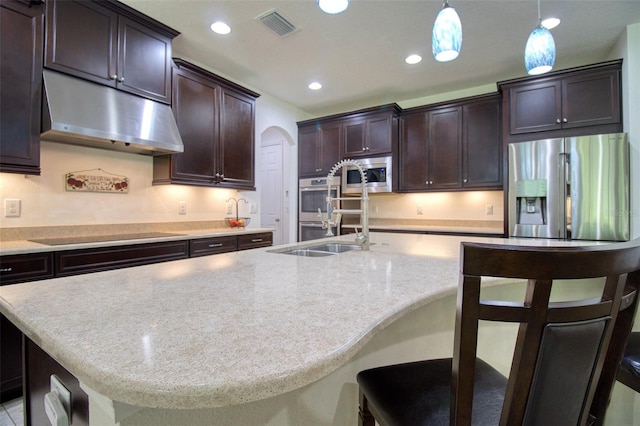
166,69,220,185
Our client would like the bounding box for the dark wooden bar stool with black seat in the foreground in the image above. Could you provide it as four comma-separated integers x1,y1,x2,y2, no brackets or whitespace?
357,240,640,426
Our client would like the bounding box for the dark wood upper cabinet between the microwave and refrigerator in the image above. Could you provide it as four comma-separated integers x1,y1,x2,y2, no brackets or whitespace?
398,94,502,192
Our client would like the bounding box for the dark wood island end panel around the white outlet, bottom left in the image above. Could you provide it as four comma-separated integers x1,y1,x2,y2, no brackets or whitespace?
24,337,89,426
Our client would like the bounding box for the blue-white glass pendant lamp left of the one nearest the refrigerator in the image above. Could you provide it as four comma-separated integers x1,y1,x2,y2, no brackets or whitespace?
431,0,462,62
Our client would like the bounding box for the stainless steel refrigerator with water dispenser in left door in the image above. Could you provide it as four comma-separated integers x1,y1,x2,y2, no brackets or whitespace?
508,133,630,241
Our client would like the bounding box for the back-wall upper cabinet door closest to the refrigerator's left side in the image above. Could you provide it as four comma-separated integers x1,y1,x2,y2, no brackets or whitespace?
462,97,502,188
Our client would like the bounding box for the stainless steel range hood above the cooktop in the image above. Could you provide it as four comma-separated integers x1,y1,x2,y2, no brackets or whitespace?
41,70,184,155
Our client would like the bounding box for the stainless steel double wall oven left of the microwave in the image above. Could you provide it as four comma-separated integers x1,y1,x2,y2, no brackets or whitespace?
298,177,340,241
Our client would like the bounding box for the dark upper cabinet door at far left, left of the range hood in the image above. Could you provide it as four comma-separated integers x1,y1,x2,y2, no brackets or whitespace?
0,1,44,174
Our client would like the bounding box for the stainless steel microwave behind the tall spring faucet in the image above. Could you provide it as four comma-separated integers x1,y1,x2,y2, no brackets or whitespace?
342,156,393,194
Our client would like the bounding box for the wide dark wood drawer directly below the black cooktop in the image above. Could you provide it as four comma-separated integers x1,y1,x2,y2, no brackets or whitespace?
54,241,189,277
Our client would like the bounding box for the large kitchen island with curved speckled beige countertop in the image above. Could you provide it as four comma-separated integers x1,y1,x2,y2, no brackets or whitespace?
0,233,638,425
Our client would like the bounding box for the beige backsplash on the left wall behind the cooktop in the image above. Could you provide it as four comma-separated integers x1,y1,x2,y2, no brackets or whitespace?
0,141,240,227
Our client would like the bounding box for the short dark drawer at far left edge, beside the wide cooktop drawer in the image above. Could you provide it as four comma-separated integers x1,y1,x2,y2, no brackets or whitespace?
0,253,53,285
